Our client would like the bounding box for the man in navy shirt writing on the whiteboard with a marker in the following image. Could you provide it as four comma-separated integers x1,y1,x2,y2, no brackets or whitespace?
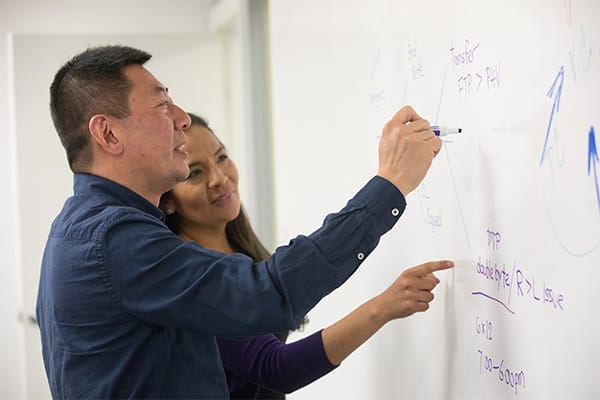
37,46,447,398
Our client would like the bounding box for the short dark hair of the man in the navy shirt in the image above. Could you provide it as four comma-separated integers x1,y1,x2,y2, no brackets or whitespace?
50,46,152,172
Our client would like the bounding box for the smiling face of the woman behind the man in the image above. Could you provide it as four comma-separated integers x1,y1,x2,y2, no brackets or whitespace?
168,125,240,232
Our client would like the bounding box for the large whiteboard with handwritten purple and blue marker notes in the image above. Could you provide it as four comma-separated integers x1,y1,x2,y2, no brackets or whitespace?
269,0,600,400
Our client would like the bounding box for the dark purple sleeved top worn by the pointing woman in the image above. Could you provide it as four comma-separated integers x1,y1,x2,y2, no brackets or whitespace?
217,331,336,399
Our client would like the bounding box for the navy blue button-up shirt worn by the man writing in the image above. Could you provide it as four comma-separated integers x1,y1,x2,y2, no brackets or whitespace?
37,174,405,399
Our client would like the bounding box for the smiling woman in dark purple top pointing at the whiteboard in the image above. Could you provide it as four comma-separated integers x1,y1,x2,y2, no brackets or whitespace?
161,114,451,399
